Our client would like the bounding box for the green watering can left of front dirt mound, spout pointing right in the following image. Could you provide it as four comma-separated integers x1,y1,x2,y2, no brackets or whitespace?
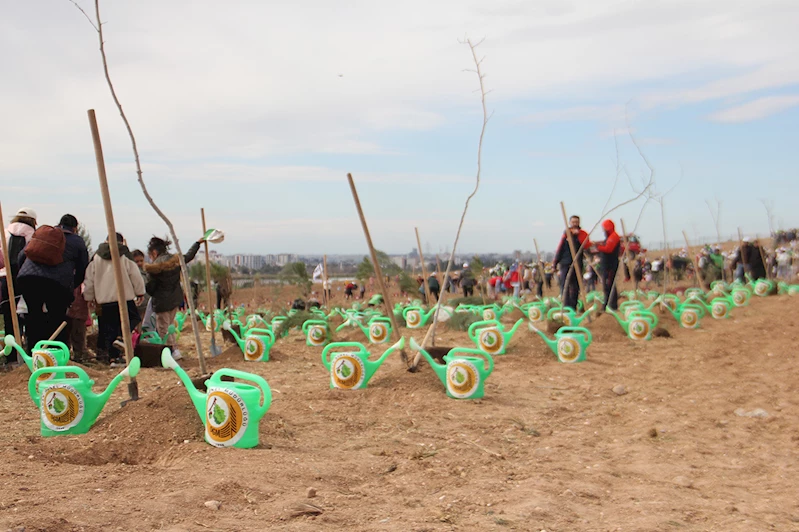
28,356,141,436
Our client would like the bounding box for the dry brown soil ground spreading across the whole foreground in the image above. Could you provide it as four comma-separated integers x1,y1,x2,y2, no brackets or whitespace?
0,286,799,531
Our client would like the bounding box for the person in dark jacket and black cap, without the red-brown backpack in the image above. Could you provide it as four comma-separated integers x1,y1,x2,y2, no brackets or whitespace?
18,214,89,349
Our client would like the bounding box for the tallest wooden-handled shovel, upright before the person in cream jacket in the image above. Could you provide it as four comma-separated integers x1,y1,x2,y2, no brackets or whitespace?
88,109,138,401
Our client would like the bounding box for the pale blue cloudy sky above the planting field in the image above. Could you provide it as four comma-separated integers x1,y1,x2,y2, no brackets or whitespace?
0,0,799,253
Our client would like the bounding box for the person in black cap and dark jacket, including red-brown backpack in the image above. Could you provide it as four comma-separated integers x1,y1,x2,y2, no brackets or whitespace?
18,214,89,348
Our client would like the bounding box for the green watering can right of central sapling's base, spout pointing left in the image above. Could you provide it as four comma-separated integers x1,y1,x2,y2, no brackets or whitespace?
410,338,494,399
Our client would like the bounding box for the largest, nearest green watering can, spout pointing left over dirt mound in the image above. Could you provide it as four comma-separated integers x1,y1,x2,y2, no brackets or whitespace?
161,349,272,449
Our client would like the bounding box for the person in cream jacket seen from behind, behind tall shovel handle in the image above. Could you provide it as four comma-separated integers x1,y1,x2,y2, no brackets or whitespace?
83,233,145,363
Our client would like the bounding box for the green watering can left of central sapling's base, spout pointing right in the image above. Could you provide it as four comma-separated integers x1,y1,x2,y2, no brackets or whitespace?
322,338,405,390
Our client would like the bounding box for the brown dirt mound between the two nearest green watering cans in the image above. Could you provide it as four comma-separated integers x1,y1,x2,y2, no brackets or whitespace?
21,386,204,466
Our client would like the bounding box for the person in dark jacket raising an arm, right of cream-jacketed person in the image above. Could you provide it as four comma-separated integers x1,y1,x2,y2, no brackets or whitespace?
144,236,202,360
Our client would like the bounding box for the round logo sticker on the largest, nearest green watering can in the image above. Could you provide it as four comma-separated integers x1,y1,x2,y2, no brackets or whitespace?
205,387,250,447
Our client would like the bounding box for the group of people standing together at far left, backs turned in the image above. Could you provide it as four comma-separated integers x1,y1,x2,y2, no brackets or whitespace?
0,208,202,365
